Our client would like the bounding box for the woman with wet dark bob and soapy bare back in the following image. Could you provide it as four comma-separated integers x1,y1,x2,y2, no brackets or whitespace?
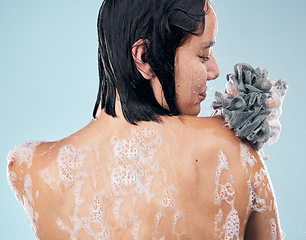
8,0,281,239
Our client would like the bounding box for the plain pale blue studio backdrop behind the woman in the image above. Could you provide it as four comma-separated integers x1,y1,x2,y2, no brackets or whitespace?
0,0,306,240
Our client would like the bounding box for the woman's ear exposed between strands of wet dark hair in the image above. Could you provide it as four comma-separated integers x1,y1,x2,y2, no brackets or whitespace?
132,39,155,80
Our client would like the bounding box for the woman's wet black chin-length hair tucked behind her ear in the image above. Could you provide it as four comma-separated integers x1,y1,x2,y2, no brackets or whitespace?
93,0,207,124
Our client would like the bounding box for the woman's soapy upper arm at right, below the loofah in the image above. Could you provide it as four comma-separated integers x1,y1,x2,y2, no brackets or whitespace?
245,153,283,240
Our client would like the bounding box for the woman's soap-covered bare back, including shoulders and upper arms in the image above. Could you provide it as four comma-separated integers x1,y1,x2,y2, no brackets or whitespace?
8,114,281,239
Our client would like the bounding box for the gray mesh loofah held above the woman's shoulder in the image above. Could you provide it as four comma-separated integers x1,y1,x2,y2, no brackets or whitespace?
212,63,288,150
